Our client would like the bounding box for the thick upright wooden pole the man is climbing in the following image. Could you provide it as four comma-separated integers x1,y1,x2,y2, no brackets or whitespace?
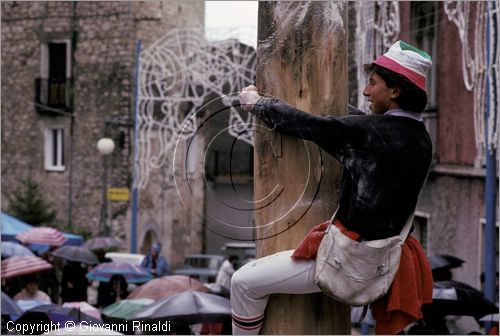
254,1,350,335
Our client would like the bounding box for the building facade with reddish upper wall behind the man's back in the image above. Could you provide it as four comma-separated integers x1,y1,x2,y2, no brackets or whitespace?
394,2,498,288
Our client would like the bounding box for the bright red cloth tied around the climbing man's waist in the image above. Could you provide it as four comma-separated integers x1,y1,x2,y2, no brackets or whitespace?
292,220,433,335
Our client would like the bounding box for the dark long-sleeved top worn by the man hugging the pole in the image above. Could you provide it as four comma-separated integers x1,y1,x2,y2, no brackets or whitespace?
252,98,432,240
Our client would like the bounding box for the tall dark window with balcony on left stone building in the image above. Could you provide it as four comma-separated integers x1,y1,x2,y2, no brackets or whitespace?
36,40,71,110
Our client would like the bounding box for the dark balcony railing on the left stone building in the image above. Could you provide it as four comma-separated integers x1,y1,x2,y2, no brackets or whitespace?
35,78,73,114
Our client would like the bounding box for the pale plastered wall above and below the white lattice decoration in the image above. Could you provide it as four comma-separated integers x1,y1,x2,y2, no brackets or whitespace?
131,0,205,269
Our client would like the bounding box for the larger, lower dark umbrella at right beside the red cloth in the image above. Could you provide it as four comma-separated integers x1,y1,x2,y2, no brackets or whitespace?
424,280,498,319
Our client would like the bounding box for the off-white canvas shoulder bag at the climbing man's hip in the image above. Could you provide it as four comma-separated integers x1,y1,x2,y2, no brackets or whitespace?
314,208,415,306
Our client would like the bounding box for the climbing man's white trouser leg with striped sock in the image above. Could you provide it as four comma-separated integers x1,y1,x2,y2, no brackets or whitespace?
231,250,321,335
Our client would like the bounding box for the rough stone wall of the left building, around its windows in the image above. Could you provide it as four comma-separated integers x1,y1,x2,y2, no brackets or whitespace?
2,2,134,236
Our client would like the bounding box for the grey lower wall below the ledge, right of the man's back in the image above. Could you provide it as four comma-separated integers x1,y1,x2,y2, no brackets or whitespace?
419,172,485,288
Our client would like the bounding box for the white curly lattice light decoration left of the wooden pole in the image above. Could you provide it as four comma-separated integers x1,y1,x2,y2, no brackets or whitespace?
135,28,256,188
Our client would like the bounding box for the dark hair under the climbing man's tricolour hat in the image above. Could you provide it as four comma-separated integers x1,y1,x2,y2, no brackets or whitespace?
365,64,427,113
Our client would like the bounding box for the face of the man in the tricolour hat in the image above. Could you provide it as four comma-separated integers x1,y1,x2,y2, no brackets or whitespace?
363,72,399,114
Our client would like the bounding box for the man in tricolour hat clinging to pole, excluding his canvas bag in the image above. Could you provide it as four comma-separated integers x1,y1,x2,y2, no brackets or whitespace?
231,41,432,334
